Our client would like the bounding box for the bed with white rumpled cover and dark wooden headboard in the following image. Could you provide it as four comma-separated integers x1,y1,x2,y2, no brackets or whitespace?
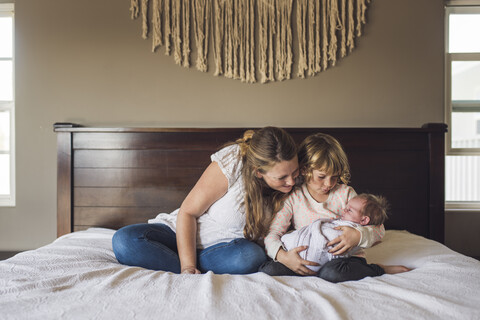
0,123,480,319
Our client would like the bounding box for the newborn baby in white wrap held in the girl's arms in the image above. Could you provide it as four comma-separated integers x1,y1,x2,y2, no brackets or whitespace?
281,193,388,272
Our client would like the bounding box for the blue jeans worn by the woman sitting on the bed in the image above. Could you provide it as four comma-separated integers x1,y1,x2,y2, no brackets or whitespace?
112,223,267,274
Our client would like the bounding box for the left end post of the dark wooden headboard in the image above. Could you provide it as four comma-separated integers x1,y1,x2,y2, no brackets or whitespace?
53,123,77,237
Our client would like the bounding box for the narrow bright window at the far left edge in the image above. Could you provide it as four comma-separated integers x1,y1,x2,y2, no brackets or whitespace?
0,3,15,206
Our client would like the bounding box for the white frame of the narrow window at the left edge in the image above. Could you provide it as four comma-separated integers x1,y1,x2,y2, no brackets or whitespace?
0,3,16,207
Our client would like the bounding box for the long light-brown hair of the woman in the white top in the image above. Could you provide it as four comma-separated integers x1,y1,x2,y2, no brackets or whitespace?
236,127,297,241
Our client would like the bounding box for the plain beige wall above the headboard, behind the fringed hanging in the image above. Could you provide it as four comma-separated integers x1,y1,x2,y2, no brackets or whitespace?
0,0,464,250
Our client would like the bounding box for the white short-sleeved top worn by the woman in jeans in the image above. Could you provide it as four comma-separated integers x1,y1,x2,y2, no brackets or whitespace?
148,144,245,249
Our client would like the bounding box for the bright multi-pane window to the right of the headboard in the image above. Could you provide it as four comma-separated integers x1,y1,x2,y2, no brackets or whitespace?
445,1,480,208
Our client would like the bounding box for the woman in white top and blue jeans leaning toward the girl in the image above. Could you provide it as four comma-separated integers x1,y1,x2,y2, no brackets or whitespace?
113,127,298,274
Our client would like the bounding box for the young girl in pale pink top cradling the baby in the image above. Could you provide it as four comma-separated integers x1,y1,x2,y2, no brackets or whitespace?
259,133,406,282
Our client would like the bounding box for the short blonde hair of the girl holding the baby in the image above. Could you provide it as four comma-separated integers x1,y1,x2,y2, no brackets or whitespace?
298,133,350,184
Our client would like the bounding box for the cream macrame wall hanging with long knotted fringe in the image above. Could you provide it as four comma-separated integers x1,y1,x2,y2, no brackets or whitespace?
130,0,370,83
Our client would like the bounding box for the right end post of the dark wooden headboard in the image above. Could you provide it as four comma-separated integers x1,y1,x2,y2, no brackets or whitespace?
422,123,447,243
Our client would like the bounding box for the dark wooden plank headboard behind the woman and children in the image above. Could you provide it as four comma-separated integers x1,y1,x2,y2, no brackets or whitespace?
54,123,446,243
